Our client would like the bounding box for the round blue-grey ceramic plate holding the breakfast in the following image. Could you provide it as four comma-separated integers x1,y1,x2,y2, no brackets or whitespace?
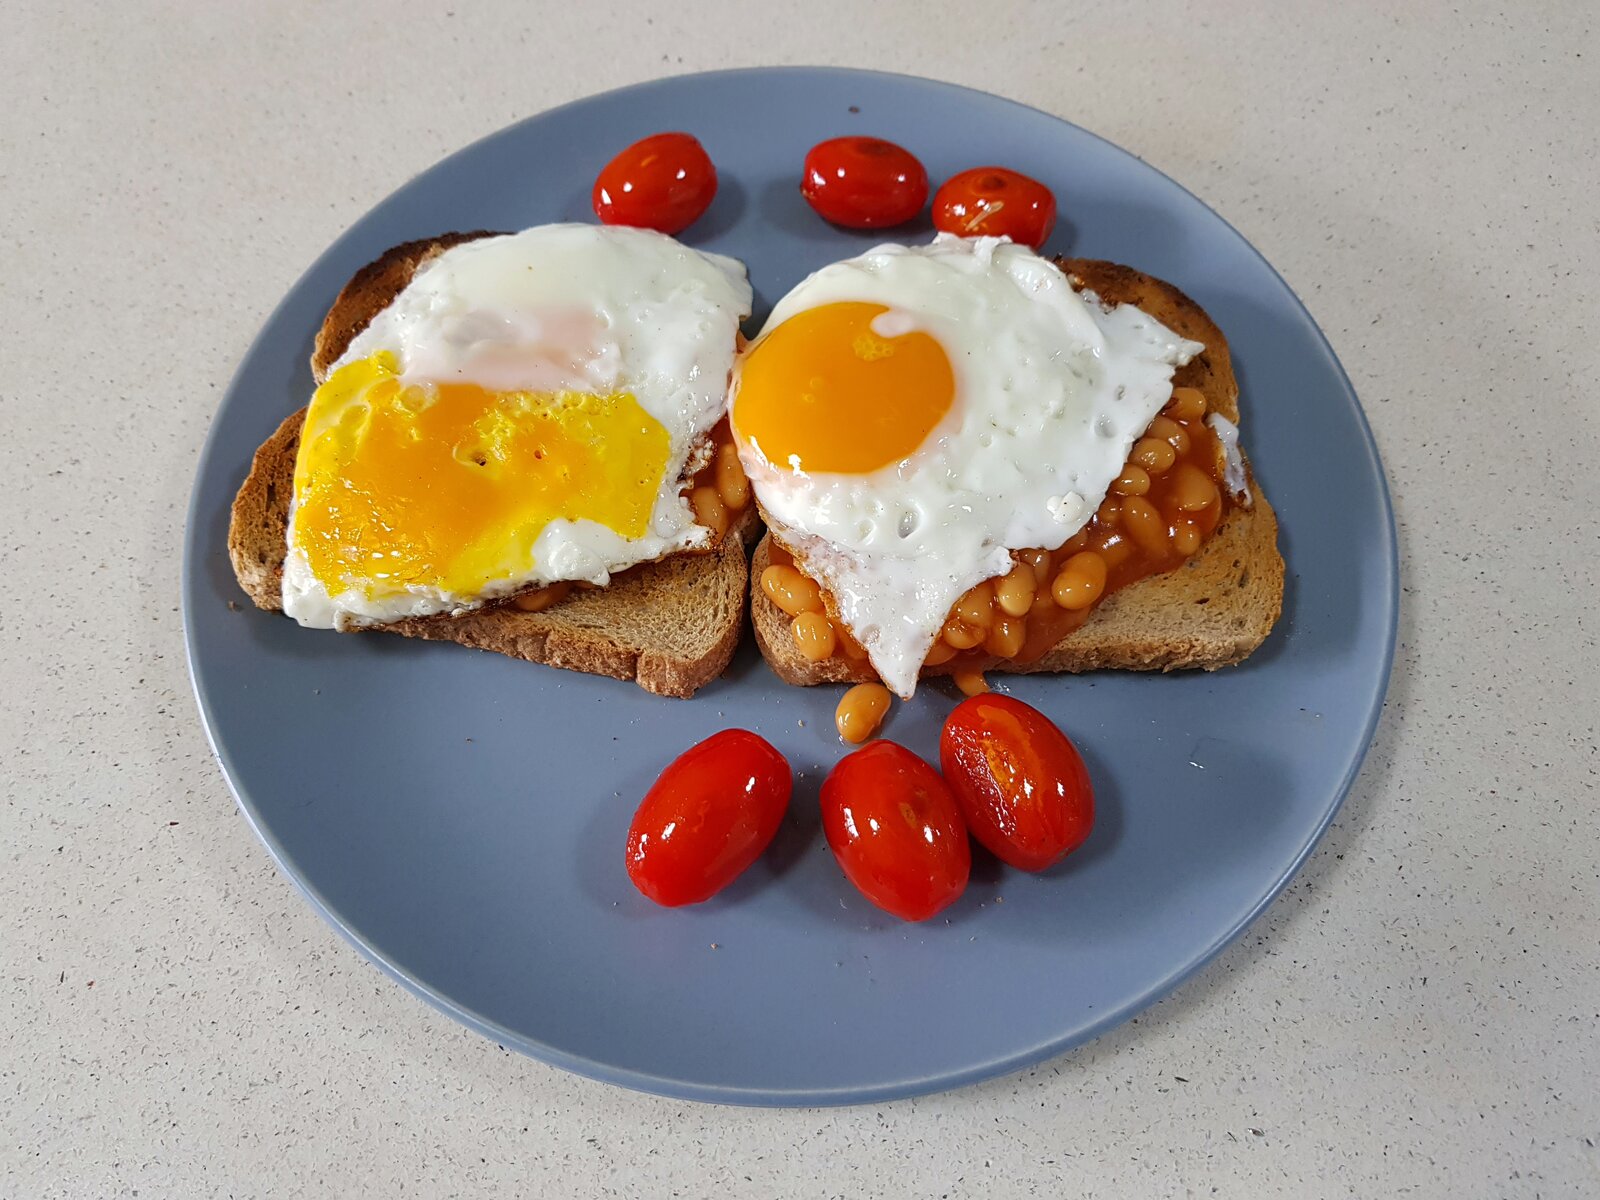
184,69,1397,1104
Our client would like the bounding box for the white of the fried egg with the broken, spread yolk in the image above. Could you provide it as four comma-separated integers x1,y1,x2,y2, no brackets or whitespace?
283,224,750,629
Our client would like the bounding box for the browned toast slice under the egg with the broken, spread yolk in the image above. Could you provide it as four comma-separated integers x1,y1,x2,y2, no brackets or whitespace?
227,234,757,696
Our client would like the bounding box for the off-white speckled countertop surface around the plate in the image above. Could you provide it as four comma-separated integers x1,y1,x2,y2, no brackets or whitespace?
0,0,1600,1197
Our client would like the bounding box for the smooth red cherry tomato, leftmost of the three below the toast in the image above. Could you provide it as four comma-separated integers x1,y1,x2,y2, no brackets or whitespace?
627,730,794,907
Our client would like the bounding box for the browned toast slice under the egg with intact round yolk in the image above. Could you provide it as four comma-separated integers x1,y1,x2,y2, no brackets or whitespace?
750,259,1283,686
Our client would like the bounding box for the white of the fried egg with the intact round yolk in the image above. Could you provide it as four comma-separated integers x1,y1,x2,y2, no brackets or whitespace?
734,234,1205,696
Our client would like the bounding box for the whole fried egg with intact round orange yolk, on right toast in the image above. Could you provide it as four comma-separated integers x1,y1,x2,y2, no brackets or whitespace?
730,234,1203,698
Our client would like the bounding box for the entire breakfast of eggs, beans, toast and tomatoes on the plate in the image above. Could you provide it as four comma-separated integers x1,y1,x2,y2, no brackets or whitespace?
229,133,1283,922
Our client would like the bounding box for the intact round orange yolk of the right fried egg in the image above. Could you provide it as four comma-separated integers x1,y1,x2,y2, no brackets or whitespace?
733,301,955,475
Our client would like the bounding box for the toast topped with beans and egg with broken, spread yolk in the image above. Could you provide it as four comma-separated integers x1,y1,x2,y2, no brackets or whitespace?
229,224,768,696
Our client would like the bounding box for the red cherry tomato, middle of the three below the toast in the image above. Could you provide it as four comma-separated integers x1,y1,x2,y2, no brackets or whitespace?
822,741,973,922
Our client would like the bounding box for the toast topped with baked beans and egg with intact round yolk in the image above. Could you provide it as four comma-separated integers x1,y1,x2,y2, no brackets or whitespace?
730,234,1283,741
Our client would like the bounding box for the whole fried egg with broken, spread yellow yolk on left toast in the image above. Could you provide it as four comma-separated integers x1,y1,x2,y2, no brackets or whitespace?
283,224,750,629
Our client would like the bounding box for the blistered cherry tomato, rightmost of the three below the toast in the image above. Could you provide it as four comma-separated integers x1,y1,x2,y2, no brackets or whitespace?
939,693,1094,870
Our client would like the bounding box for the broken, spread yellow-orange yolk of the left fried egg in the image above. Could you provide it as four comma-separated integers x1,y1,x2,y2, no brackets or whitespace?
294,352,669,598
